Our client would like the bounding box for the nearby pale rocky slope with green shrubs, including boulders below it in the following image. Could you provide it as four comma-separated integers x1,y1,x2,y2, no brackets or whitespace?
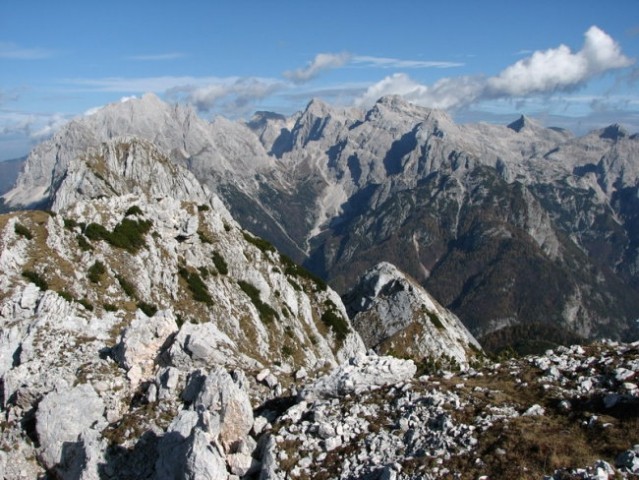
0,139,364,479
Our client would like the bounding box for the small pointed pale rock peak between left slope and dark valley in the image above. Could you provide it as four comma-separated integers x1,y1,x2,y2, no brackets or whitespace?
344,263,481,368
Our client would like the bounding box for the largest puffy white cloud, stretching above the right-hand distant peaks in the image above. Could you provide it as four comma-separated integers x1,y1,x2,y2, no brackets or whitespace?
357,26,634,109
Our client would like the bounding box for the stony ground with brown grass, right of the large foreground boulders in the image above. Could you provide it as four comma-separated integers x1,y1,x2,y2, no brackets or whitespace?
258,342,639,479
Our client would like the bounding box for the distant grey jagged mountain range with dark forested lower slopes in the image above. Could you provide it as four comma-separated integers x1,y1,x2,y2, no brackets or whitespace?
3,95,639,351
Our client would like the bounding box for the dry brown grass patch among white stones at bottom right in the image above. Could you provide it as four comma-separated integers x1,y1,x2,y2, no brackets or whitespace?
445,354,639,480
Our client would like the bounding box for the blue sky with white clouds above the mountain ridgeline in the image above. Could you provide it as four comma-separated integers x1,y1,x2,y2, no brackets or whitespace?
0,0,639,160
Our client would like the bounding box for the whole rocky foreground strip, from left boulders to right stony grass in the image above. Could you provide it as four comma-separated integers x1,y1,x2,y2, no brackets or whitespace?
0,324,639,480
